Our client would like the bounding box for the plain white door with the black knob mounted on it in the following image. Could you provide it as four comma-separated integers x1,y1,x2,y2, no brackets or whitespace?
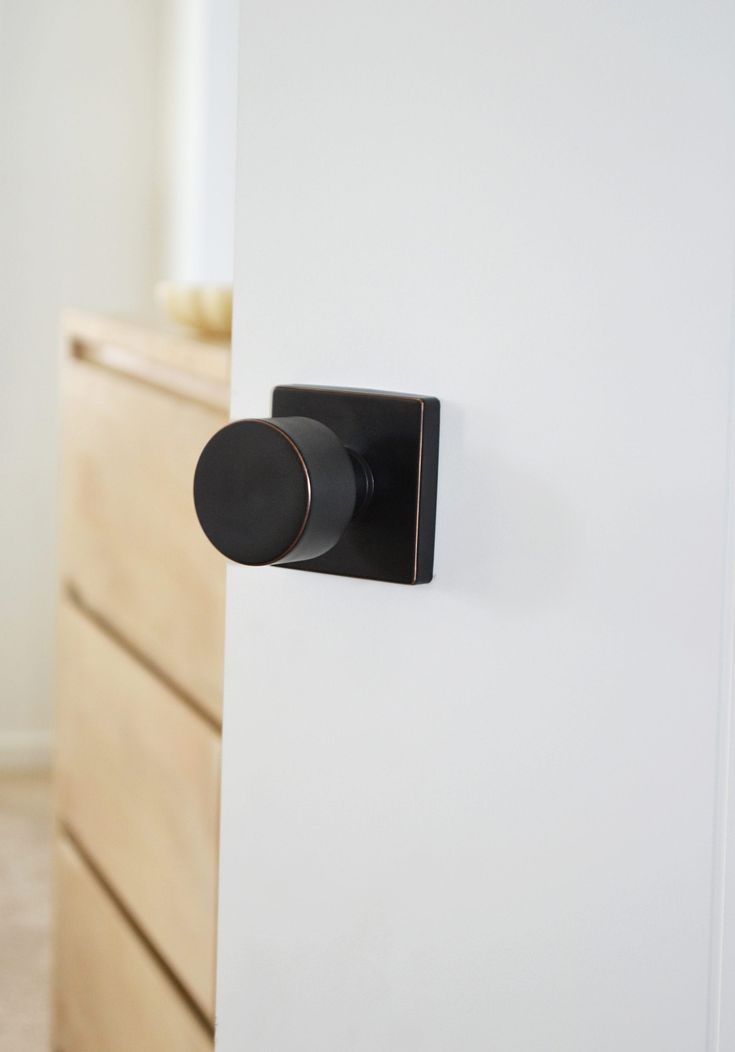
218,0,735,1052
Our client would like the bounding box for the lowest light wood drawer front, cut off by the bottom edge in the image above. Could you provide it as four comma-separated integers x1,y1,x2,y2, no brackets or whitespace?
54,838,213,1052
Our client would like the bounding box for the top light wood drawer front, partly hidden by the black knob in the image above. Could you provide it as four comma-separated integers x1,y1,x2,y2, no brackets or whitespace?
63,357,225,720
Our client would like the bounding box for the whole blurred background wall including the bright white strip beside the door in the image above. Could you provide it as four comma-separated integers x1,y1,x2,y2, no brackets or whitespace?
0,0,238,767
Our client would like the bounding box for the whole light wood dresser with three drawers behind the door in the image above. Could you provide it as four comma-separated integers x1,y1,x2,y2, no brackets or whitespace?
54,315,229,1052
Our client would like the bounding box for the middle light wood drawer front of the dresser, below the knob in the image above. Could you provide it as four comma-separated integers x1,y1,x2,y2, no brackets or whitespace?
57,602,220,1017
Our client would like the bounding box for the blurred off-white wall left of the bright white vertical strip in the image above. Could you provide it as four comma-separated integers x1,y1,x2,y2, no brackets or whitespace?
0,0,167,765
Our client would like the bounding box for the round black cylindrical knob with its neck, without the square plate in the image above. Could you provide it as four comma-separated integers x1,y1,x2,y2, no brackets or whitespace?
193,417,371,566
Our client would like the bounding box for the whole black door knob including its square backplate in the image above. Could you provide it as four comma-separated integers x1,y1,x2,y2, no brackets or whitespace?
193,386,438,584
